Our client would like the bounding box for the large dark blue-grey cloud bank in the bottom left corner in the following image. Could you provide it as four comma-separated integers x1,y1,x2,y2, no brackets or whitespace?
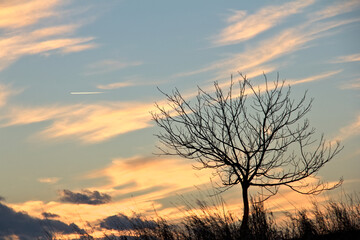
0,203,79,240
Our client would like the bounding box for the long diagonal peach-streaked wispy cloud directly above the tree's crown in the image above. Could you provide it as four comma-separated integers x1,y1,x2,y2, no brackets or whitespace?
174,15,360,84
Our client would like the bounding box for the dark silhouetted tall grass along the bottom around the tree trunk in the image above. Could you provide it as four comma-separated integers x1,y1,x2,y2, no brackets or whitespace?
45,195,360,240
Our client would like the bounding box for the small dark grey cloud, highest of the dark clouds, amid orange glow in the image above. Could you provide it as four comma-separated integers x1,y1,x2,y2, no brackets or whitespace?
60,189,111,205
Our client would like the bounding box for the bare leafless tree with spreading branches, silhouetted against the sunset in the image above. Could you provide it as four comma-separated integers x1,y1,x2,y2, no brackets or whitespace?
152,74,342,231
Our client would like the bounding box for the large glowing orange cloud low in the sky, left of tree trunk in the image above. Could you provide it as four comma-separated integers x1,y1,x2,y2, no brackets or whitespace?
9,156,217,229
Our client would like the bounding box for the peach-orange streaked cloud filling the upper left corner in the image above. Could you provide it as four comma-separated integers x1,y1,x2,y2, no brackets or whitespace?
0,0,96,71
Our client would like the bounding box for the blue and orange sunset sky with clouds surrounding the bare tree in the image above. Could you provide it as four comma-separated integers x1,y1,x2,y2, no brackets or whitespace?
0,0,360,239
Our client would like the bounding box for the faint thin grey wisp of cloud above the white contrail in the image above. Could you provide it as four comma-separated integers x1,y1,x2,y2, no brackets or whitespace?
85,59,143,75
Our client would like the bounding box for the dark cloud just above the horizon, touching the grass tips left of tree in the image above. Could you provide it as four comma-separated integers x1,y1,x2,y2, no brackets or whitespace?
100,214,156,230
